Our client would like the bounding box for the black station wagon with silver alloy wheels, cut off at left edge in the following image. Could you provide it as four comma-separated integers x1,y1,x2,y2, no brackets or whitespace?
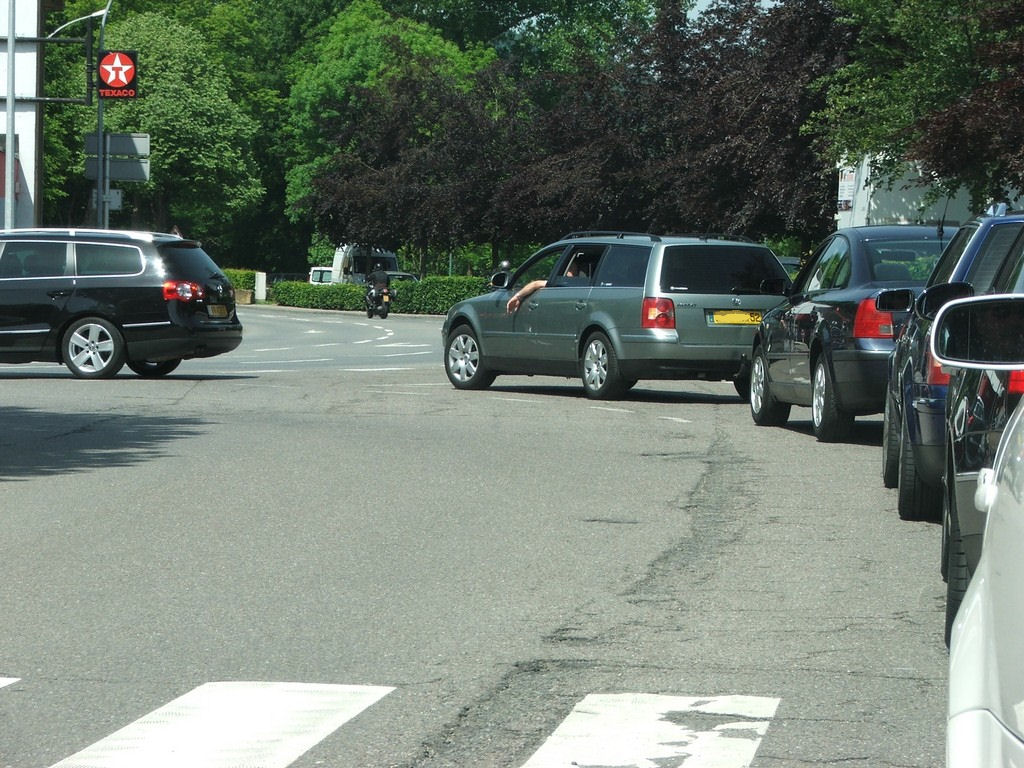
0,229,242,379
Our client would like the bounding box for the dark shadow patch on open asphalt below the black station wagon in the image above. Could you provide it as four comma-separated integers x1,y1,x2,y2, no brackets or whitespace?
0,408,204,481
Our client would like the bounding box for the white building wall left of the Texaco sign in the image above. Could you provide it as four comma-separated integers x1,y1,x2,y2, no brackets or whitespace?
0,0,42,226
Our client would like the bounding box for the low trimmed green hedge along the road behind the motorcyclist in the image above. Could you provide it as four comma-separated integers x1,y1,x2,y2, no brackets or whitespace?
268,270,490,314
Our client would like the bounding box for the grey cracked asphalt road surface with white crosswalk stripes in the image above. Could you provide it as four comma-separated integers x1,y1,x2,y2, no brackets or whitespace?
0,306,947,768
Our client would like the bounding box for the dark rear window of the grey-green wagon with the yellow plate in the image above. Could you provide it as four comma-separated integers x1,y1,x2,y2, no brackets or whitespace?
662,245,788,294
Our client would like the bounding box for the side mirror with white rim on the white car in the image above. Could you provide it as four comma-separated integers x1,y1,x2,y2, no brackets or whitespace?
931,294,1024,371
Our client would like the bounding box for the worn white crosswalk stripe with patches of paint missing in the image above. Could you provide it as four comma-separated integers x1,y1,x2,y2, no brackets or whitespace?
522,693,779,768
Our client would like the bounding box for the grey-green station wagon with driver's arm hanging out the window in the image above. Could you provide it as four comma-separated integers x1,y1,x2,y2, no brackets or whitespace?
441,232,790,399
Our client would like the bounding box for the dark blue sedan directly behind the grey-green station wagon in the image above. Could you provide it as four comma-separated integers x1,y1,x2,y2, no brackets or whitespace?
751,225,944,441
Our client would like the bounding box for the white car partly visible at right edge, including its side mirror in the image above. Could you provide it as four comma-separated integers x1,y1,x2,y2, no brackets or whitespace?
932,294,1024,768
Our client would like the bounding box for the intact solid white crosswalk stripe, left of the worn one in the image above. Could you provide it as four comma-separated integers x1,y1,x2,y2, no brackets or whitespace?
52,682,394,768
